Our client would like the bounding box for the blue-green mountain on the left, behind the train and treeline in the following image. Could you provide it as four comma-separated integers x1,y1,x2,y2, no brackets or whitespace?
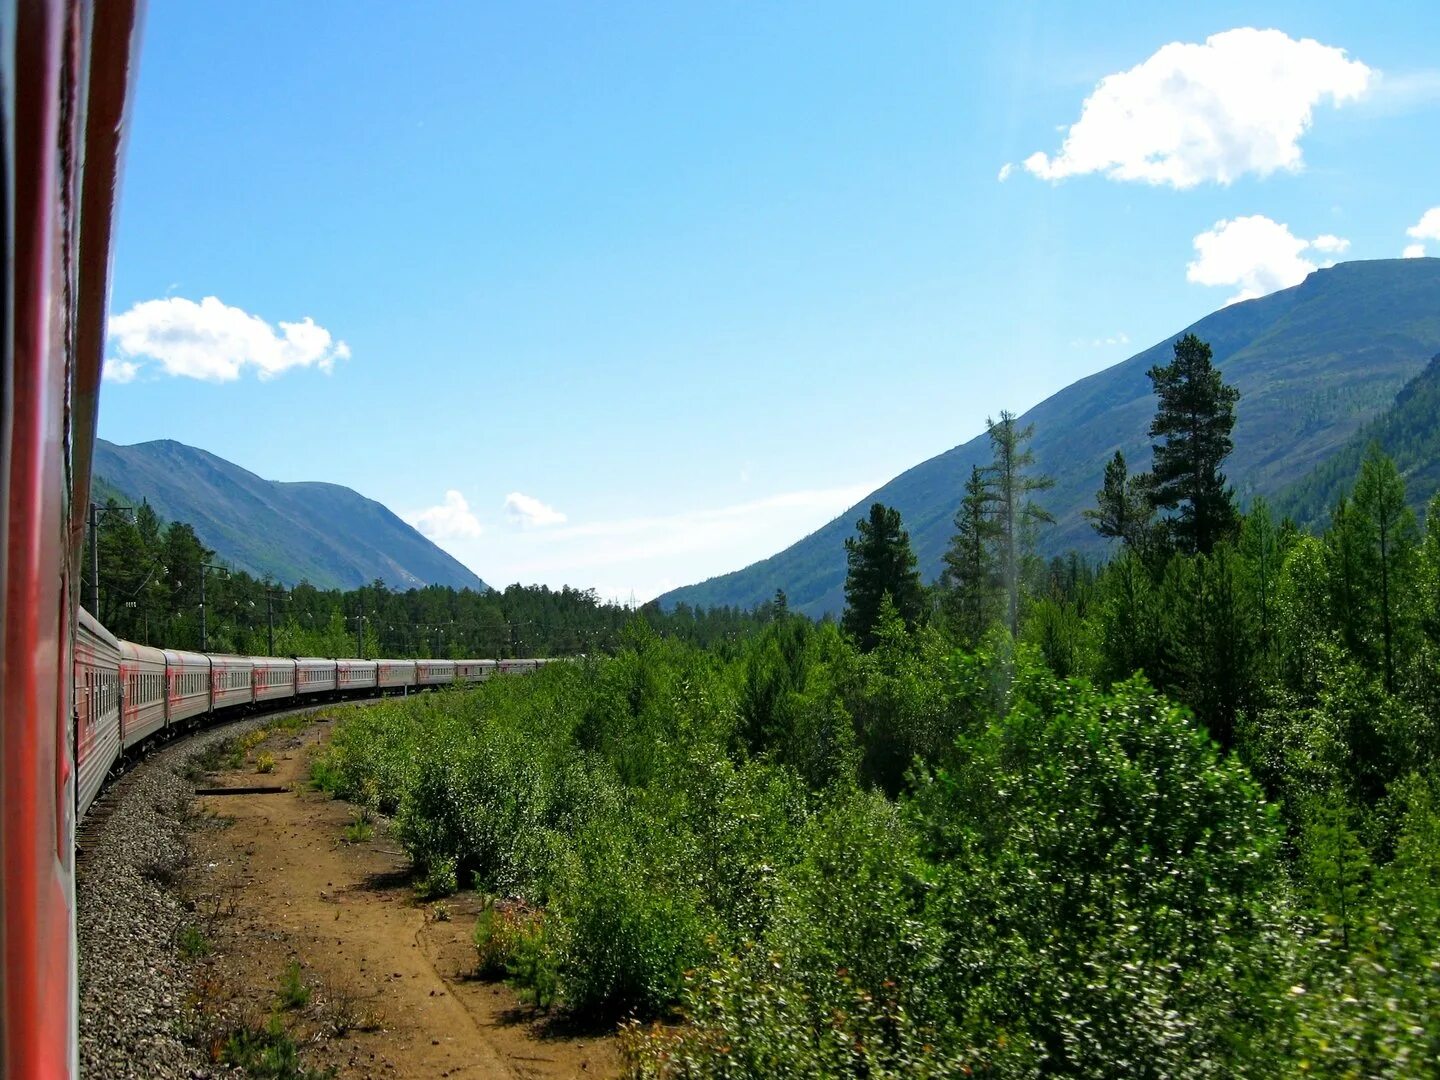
94,439,487,590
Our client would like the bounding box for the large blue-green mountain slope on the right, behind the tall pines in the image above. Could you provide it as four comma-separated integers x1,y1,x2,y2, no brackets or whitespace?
660,259,1440,615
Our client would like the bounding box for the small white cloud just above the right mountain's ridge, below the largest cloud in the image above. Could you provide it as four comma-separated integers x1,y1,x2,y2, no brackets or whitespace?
1185,213,1349,304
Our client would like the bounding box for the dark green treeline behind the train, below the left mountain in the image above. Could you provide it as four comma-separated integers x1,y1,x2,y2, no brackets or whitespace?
81,512,770,658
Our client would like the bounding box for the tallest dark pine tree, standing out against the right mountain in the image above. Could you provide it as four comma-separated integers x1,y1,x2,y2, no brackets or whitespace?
1148,334,1240,554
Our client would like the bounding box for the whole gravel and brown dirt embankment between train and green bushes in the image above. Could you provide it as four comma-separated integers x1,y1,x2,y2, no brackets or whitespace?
79,710,618,1080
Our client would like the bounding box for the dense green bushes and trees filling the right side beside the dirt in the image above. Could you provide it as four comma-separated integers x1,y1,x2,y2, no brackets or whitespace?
315,337,1440,1077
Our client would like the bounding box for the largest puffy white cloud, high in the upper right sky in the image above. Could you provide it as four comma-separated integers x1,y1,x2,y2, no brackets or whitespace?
1024,27,1375,187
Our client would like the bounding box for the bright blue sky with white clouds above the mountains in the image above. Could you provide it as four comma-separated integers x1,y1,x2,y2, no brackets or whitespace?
101,0,1440,600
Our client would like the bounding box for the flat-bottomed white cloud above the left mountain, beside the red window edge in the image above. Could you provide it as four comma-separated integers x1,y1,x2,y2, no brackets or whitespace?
109,297,350,383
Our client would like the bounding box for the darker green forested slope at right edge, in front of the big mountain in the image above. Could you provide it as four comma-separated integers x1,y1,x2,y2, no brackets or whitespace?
1274,354,1440,528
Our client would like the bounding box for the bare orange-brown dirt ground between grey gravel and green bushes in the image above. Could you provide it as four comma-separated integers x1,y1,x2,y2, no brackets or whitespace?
192,723,619,1080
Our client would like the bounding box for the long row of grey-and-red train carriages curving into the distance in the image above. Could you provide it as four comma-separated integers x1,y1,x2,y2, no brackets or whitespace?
73,608,553,818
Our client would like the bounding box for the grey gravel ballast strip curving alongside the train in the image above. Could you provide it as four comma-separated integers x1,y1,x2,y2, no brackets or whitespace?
75,717,286,1080
